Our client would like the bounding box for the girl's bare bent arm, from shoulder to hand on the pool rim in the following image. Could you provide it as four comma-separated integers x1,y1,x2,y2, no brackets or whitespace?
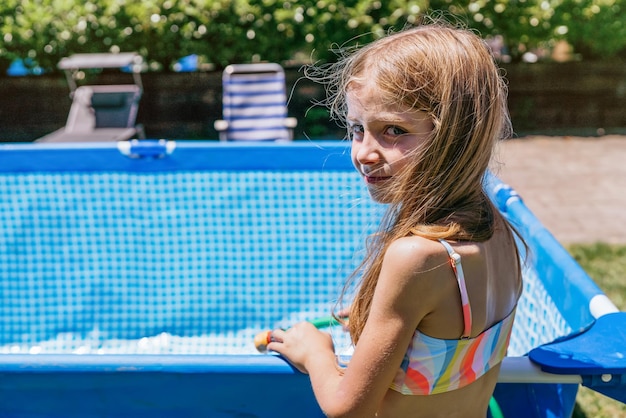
268,237,442,418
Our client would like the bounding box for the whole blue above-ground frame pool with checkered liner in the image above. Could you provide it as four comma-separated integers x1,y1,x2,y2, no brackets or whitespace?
0,141,626,418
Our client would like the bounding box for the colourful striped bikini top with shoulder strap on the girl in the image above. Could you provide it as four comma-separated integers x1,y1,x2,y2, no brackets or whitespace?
391,240,515,395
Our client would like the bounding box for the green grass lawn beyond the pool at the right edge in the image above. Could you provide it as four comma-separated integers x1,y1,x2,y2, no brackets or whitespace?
567,243,626,418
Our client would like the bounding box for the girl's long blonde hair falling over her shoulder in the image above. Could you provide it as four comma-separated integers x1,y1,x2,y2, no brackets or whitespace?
310,23,511,343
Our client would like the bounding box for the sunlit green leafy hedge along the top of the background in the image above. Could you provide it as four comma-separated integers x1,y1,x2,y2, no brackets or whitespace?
0,0,626,70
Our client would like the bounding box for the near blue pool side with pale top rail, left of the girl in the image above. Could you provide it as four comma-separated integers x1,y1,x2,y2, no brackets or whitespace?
0,355,324,418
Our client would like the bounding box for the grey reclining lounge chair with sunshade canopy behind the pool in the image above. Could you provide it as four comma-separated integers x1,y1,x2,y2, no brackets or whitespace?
37,53,144,142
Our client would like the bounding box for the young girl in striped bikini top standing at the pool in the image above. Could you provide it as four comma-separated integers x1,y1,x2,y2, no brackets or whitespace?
267,24,522,418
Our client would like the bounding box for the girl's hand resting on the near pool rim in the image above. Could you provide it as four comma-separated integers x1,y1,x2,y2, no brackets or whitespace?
267,322,335,374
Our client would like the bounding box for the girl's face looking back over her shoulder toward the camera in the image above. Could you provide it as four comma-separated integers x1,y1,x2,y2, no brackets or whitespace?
346,81,434,203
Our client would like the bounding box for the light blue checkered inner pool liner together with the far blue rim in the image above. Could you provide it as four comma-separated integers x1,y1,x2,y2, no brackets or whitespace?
0,141,571,355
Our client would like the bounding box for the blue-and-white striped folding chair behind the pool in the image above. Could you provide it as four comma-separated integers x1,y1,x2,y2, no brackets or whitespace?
214,63,298,141
